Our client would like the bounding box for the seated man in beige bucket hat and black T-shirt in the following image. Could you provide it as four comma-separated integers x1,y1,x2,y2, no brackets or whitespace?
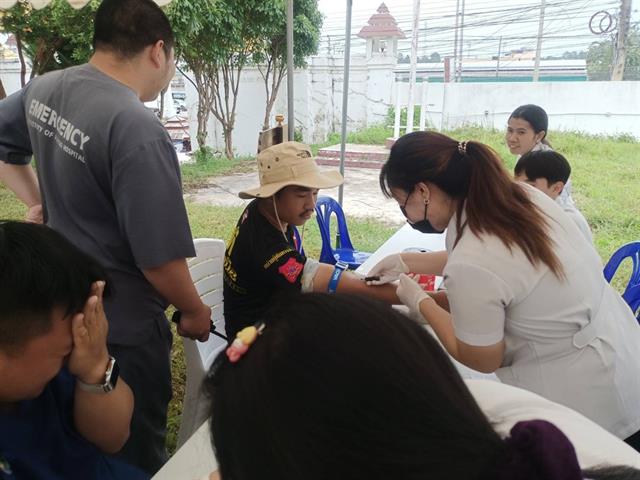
224,142,398,339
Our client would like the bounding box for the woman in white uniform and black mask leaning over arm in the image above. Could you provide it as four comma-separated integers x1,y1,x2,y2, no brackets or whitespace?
369,132,640,450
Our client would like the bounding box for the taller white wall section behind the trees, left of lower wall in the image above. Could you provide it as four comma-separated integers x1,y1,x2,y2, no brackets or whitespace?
185,56,395,155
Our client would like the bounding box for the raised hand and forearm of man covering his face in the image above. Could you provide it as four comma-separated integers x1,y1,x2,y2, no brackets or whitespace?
69,282,133,453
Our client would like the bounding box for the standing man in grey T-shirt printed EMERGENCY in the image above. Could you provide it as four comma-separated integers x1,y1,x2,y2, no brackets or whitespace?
0,0,211,473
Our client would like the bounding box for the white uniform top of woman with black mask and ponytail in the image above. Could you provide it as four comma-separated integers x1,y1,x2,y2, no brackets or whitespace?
443,184,640,438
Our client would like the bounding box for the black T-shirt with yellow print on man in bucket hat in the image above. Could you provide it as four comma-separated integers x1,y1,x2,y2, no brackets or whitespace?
224,200,307,341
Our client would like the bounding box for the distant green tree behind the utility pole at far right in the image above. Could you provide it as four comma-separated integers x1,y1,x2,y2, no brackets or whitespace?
587,25,640,80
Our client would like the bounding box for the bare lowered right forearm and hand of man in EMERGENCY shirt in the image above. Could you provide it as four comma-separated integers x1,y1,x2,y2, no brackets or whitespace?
143,258,211,342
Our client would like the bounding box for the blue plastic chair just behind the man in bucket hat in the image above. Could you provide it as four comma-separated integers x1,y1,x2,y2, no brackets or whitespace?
316,197,371,270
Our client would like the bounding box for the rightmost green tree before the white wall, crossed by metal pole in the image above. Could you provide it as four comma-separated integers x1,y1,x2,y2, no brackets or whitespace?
253,0,323,130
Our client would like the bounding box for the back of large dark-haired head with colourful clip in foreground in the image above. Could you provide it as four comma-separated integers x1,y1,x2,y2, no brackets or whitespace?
207,294,504,480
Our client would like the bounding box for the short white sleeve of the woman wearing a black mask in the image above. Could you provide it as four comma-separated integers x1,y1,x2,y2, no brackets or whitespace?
443,262,513,347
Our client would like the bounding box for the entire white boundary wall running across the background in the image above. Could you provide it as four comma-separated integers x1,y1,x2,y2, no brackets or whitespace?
187,62,640,155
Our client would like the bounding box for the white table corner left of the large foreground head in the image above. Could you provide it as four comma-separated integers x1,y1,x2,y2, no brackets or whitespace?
152,421,218,480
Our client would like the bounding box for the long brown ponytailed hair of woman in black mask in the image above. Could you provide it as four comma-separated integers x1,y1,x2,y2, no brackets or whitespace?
380,132,563,277
